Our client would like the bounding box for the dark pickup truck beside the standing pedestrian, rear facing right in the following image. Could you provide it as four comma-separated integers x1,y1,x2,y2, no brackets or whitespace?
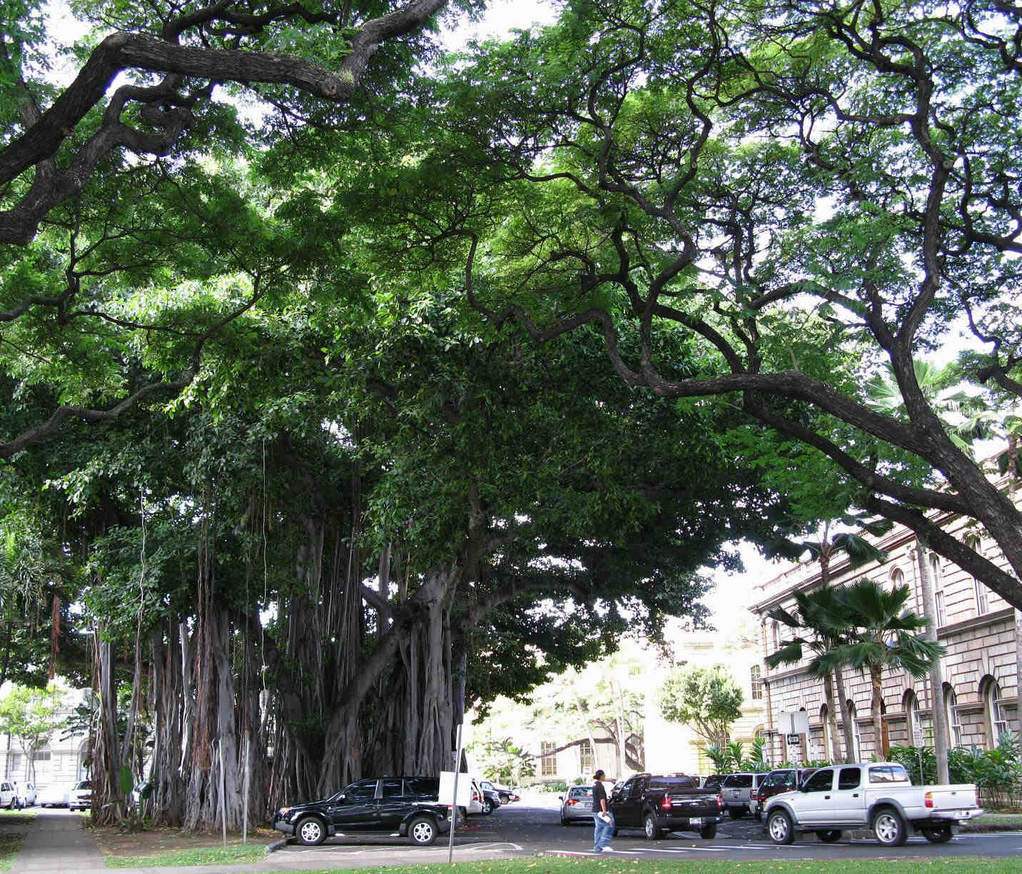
610,774,724,840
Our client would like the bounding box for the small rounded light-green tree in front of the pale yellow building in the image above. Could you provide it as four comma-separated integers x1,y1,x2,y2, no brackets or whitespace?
659,665,744,758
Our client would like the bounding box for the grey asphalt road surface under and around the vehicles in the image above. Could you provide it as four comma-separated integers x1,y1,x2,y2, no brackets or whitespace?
274,794,1022,867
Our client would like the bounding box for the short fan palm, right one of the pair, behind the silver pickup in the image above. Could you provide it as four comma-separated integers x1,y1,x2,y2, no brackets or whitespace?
820,579,944,755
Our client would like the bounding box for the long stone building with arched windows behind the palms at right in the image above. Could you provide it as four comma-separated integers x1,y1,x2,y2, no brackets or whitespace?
752,504,1018,762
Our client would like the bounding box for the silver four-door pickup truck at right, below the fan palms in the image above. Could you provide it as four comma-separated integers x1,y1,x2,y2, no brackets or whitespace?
763,762,983,846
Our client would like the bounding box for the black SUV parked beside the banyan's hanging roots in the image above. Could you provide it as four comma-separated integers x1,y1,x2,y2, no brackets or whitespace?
273,777,450,846
